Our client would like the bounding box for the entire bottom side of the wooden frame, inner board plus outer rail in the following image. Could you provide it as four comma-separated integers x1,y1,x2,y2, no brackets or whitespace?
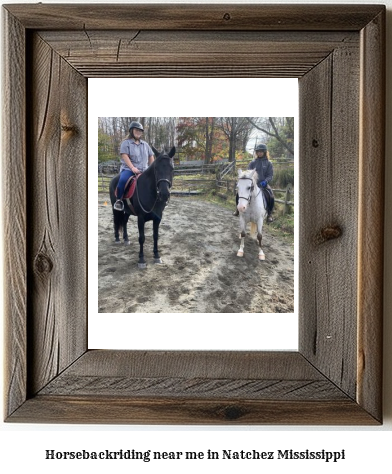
9,350,377,425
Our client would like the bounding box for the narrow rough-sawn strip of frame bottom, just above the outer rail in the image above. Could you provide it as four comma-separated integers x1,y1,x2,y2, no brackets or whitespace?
40,375,347,401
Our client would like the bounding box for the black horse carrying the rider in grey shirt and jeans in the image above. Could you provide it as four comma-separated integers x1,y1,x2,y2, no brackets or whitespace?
110,147,176,268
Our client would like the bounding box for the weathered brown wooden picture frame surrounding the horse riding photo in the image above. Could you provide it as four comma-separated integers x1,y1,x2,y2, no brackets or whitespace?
3,4,385,425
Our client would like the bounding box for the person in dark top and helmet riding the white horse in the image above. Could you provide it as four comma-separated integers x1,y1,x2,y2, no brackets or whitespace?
234,143,275,222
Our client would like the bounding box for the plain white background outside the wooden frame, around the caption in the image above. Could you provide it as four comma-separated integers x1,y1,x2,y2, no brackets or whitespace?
0,0,392,474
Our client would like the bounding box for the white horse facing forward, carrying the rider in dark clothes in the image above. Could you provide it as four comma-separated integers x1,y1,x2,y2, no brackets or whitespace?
237,170,267,260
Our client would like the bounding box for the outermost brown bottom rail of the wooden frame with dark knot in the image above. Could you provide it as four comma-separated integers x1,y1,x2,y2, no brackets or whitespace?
9,395,377,425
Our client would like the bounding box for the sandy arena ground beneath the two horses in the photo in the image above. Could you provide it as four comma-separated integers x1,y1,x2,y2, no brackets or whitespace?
98,195,294,313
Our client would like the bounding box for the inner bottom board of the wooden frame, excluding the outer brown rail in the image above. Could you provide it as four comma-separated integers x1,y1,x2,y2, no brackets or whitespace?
36,350,346,401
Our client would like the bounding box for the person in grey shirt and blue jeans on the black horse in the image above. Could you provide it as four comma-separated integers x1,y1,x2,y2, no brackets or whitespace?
113,121,155,211
